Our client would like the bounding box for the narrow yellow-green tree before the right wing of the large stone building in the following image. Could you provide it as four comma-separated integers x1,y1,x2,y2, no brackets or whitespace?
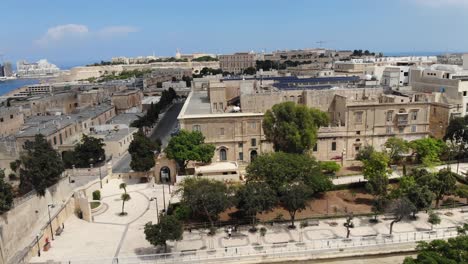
363,152,390,196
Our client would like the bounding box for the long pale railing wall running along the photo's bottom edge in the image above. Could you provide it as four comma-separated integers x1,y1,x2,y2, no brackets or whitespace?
50,227,458,264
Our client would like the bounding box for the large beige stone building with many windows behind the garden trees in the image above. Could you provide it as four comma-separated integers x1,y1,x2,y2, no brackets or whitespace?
178,77,449,166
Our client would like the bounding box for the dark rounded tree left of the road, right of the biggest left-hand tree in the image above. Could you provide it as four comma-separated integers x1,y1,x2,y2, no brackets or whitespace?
72,135,106,168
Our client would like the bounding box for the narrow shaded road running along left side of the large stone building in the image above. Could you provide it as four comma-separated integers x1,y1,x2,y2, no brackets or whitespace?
112,102,184,173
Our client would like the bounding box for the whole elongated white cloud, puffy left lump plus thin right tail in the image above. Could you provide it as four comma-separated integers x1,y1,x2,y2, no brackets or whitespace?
35,24,138,47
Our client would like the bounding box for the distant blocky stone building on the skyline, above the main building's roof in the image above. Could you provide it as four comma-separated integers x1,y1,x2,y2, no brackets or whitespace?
219,52,257,74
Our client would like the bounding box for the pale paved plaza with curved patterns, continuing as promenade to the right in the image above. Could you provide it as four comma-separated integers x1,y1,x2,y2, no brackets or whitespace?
31,179,468,262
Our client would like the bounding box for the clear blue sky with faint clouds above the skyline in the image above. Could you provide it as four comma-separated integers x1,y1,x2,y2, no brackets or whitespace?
0,0,468,67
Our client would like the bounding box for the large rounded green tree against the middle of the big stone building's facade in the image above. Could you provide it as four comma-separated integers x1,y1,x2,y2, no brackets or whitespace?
263,102,328,154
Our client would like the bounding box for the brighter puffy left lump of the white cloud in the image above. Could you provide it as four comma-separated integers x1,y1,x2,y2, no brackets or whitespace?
36,24,89,45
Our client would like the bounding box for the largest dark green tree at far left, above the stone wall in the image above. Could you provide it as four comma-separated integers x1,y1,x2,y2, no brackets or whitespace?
19,134,64,196
